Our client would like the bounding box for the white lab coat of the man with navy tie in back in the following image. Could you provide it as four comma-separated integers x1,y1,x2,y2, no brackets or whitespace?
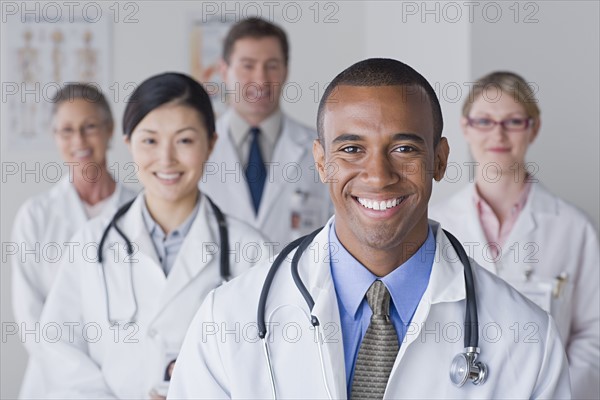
200,110,331,251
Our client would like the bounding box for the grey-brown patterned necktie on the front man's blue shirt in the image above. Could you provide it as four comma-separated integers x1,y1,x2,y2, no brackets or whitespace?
351,280,399,400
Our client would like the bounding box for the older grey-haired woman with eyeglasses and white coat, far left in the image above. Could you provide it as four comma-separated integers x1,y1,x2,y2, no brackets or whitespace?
11,83,135,398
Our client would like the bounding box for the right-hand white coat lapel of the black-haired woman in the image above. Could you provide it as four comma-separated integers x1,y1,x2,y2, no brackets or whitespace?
152,195,220,315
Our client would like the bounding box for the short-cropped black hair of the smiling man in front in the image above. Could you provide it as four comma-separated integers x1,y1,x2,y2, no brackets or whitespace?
317,58,444,146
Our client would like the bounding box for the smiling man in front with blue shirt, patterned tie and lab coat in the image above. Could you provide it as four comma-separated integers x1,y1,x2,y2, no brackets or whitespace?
169,59,570,399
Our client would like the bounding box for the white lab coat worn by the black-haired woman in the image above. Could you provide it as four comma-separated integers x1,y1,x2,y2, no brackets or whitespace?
39,194,267,399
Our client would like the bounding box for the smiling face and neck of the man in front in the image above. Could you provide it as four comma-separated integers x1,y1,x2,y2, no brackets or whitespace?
313,85,448,267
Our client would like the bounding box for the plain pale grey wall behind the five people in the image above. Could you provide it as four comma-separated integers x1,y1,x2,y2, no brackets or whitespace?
0,1,600,399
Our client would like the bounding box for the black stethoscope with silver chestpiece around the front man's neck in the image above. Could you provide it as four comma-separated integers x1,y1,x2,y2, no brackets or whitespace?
257,228,488,399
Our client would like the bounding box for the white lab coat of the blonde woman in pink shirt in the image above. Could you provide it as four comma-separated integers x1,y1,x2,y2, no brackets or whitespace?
429,183,600,399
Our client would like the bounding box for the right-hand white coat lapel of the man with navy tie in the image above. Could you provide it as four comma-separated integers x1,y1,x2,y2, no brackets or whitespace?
258,116,309,226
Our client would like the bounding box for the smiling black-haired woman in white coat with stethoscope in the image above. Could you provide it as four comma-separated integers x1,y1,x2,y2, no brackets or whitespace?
35,73,267,399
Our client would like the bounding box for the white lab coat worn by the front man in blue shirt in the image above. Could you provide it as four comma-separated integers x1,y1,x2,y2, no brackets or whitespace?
168,221,569,399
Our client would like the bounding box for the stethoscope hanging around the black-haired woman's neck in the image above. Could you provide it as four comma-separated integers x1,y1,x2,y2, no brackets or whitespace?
98,196,231,325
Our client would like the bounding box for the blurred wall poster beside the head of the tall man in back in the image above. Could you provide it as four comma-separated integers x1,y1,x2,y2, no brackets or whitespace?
189,15,234,116
